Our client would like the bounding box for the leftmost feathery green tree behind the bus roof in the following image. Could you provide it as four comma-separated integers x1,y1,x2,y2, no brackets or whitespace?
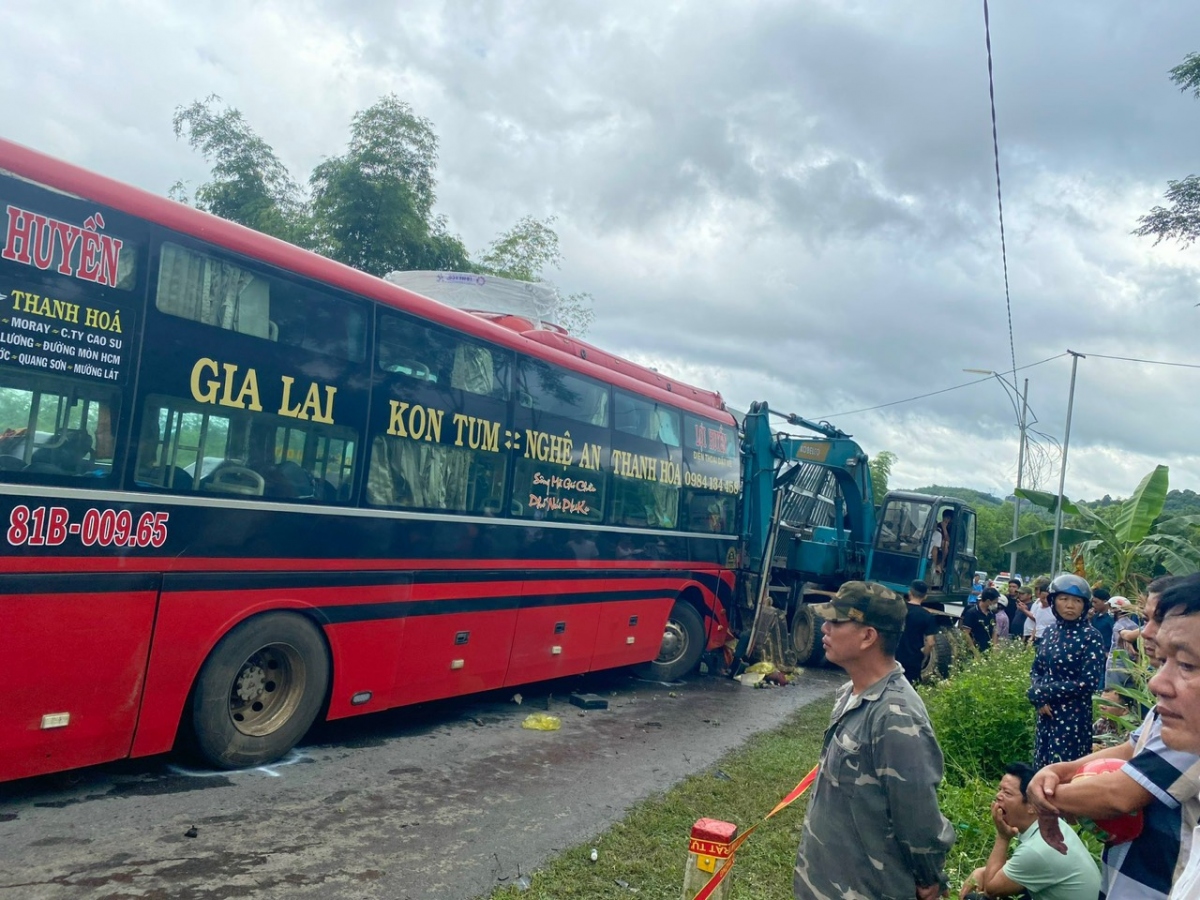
170,94,308,244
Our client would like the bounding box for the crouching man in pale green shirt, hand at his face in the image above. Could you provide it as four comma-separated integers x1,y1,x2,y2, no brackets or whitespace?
960,762,1100,900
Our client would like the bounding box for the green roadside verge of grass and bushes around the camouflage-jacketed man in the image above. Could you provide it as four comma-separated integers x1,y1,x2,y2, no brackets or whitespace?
490,643,1099,900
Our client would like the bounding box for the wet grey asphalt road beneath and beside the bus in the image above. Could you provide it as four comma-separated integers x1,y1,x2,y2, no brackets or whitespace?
0,670,841,900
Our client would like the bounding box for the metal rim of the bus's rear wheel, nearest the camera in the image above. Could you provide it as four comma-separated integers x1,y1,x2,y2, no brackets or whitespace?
229,643,307,738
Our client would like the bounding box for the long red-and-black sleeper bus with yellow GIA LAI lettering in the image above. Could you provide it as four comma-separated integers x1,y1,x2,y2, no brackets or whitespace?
0,140,740,779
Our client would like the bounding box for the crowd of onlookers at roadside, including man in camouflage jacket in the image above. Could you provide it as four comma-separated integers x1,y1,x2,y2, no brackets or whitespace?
793,574,1200,900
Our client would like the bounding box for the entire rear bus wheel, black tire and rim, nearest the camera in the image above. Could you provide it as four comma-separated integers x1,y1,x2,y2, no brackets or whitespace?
191,612,330,769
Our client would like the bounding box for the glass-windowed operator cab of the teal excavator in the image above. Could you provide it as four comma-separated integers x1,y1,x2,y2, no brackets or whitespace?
866,491,976,600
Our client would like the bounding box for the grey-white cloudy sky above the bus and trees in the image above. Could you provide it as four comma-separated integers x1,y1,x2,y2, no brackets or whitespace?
0,0,1200,498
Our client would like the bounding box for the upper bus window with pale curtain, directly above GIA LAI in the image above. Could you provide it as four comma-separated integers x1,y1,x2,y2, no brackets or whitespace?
155,244,366,361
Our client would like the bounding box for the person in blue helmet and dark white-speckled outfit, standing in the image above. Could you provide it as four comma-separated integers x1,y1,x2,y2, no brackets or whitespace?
1026,574,1108,769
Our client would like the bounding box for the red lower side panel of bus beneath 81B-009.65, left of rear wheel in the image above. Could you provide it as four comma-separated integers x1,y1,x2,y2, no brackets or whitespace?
0,572,158,780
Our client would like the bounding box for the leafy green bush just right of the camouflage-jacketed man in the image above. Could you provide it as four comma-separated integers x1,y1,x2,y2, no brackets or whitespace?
919,641,1034,791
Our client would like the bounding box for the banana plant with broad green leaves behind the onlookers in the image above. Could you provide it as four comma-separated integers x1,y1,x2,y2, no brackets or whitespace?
1003,466,1200,596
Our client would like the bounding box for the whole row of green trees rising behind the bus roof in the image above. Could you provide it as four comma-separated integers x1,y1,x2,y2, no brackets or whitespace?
168,94,594,334
